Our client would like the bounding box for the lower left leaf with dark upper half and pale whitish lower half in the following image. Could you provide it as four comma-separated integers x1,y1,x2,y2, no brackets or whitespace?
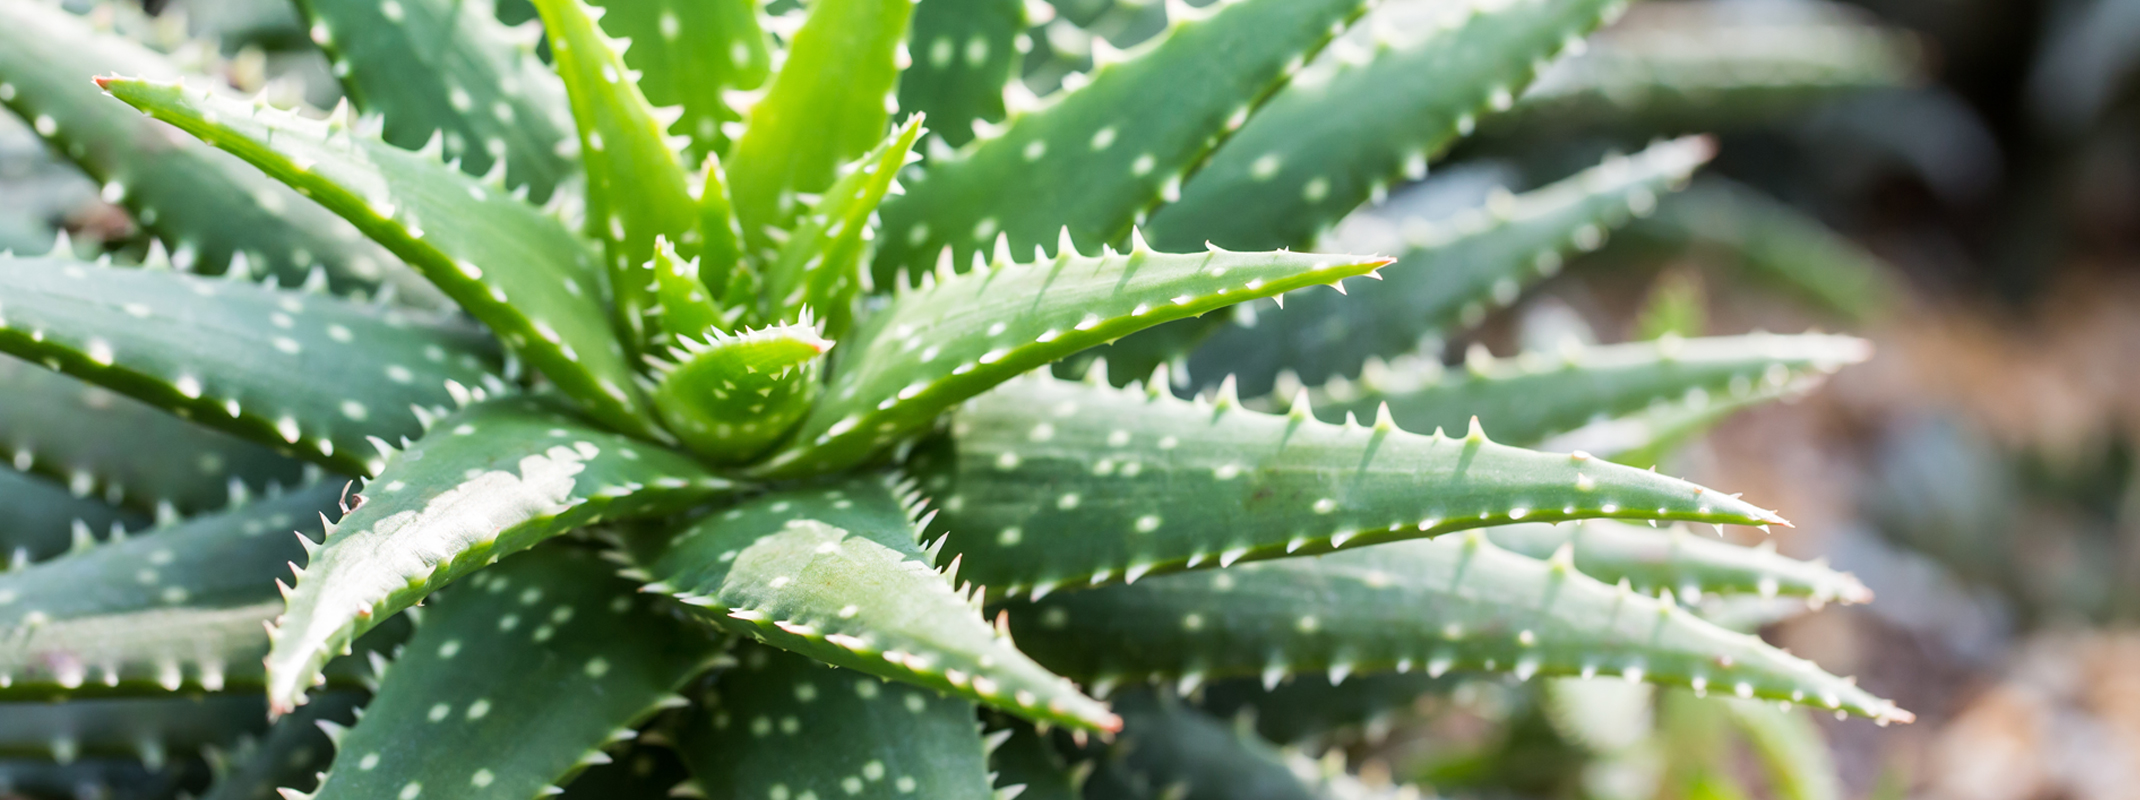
0,481,398,699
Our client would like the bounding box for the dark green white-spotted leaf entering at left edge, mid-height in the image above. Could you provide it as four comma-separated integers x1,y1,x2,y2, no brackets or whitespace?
0,257,501,475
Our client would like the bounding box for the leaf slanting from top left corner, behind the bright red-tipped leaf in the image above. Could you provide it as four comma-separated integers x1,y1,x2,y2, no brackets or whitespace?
0,2,443,306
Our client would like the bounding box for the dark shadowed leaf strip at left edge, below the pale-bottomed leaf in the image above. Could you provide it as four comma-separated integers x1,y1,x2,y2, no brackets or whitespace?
0,695,268,768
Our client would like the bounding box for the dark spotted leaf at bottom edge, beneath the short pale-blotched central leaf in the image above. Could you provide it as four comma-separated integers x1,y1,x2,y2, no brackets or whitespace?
681,646,995,800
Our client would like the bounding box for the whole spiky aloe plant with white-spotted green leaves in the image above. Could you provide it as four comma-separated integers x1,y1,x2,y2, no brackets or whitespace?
0,0,1909,800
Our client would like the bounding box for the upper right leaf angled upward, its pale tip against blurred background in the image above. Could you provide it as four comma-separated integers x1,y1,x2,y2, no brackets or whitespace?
1172,139,1714,400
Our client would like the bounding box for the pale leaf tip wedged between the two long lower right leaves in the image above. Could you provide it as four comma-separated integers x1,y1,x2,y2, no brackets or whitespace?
1485,520,1873,603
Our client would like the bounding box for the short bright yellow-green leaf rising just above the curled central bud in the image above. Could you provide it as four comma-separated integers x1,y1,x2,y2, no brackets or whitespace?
764,113,922,338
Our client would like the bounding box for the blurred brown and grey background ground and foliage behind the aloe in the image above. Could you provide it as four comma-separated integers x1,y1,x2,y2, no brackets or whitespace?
0,0,2140,800
